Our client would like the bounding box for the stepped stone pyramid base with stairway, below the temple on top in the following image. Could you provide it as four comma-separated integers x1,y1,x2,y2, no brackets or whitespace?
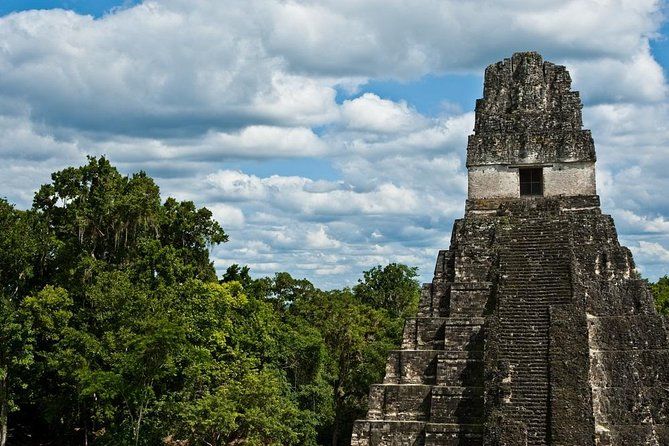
351,203,669,446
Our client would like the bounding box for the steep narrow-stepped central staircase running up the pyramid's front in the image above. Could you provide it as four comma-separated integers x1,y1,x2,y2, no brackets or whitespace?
496,218,572,446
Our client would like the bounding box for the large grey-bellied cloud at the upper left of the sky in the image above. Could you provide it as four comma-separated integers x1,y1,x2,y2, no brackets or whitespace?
0,1,336,135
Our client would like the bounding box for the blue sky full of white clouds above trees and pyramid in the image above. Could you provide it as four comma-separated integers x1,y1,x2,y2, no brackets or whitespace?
0,0,669,288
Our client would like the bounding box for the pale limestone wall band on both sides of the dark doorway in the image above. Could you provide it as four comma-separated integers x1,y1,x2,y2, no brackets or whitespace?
468,162,596,200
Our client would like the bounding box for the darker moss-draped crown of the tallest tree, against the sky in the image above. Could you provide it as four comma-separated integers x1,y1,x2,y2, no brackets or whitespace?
33,157,227,286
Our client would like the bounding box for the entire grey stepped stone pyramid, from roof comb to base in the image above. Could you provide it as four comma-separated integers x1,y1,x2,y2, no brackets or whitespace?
351,53,669,446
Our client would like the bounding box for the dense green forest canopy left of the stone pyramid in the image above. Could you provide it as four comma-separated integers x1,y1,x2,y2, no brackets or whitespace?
0,158,419,446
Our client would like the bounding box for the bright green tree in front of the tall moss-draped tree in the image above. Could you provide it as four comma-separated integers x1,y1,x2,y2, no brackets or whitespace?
76,271,186,444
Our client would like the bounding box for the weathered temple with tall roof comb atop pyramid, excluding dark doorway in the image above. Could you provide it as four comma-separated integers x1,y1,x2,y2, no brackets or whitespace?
467,53,595,199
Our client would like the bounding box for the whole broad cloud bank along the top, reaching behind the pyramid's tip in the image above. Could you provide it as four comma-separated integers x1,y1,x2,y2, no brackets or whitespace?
0,0,663,136
